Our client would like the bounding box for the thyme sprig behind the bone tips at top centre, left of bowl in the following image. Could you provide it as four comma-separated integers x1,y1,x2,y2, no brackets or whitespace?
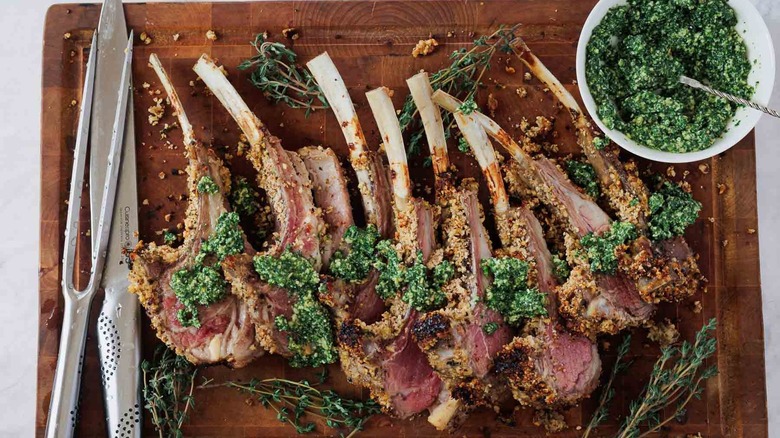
398,25,519,156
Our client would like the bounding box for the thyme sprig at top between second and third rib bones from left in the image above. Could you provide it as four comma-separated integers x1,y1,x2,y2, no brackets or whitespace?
238,34,328,116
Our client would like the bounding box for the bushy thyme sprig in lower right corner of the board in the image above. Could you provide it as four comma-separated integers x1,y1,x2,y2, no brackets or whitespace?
617,318,718,438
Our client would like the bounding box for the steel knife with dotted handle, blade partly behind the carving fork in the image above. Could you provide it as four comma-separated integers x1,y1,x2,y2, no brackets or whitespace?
90,0,142,437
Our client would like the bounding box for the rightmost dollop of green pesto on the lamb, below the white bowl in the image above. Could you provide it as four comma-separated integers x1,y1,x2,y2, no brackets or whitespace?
648,181,701,241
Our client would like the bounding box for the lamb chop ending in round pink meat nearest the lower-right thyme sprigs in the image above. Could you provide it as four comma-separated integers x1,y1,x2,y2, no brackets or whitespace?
454,106,601,410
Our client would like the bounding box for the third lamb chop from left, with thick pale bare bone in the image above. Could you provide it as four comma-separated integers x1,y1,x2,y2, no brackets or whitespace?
307,52,394,324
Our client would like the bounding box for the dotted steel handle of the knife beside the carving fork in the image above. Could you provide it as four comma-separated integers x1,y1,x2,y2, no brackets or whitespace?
97,285,142,438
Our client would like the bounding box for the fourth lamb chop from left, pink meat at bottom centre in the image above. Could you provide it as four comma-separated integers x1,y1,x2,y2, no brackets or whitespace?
339,89,444,418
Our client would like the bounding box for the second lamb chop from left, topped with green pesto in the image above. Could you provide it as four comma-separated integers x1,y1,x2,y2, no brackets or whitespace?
193,55,336,366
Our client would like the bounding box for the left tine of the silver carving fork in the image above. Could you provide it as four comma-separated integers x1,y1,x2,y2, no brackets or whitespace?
62,30,97,292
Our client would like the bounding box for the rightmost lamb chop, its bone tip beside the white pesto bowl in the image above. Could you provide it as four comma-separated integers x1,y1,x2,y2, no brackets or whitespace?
513,38,702,303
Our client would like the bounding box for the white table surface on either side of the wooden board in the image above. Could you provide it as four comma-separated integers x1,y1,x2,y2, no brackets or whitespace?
0,0,780,437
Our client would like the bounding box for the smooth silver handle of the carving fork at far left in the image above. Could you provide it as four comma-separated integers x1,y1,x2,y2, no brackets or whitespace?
46,290,94,438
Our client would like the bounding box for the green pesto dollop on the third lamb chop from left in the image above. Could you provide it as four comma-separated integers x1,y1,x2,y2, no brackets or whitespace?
330,225,379,283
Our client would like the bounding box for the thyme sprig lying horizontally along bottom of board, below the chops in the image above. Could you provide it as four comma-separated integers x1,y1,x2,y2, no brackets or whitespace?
198,377,380,437
